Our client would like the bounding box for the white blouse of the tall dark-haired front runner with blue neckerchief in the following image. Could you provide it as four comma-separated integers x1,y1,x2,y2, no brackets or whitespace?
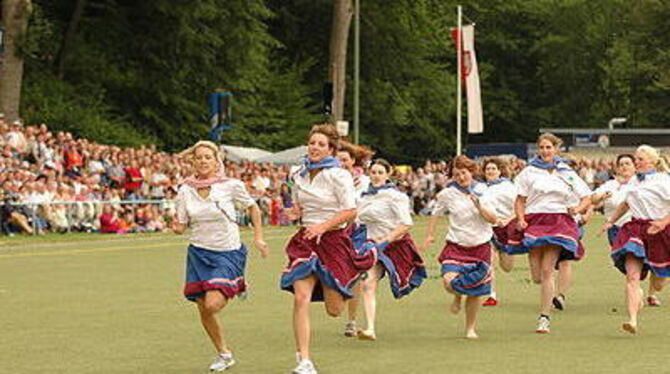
291,167,356,228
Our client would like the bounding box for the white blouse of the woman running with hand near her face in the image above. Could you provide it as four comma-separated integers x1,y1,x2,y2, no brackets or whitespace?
433,183,494,247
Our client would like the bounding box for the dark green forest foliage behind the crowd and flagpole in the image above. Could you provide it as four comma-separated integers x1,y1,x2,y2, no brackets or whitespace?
15,0,670,162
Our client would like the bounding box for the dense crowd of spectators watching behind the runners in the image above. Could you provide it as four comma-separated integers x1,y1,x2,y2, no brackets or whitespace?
0,117,628,235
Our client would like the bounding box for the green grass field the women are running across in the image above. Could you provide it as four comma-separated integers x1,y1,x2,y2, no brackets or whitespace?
0,216,670,374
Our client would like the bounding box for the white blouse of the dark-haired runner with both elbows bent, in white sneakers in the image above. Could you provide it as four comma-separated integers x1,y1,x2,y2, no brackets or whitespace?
515,164,591,214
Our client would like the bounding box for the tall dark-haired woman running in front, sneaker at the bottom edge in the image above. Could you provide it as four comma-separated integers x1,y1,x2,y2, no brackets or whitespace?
281,124,377,374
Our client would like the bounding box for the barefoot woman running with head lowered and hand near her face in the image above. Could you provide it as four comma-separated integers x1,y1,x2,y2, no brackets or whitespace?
424,156,498,339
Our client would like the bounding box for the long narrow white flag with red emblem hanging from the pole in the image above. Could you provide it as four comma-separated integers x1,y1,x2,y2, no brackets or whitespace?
462,25,484,134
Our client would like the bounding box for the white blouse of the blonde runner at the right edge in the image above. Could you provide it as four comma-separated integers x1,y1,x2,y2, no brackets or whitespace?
626,173,670,220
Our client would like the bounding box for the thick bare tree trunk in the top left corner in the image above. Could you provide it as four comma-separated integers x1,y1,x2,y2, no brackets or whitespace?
0,0,32,121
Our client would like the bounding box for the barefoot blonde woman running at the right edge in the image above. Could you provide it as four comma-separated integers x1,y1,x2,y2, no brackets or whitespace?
601,145,670,334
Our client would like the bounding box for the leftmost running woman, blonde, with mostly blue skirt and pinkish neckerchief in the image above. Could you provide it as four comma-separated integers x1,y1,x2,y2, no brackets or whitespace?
173,141,269,372
